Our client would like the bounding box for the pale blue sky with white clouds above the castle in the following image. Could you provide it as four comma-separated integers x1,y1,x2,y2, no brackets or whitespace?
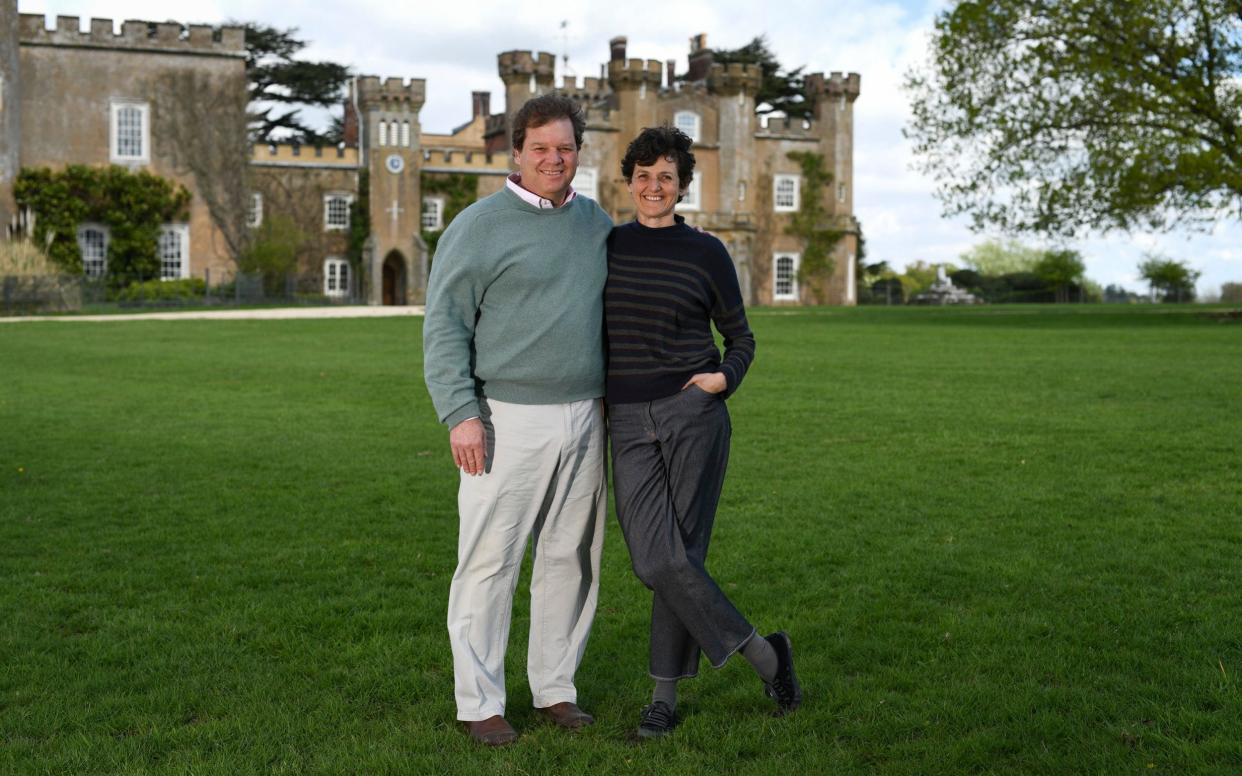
19,0,1242,296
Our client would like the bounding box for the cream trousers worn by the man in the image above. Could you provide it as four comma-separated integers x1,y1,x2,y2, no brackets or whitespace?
448,400,607,721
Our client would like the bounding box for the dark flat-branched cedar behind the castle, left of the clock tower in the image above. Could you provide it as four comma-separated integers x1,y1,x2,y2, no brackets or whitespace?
239,22,349,144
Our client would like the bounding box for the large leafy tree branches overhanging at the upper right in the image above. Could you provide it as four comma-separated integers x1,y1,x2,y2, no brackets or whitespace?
905,0,1242,236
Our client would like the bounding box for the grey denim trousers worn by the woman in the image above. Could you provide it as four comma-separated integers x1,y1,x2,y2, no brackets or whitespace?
609,386,755,679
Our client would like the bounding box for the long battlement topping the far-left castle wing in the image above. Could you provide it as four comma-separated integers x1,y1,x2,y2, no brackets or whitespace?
17,14,246,57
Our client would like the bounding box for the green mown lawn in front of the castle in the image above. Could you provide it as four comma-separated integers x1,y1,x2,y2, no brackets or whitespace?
0,307,1242,775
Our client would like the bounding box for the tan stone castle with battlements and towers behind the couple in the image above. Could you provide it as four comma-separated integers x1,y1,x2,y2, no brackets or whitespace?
0,0,859,304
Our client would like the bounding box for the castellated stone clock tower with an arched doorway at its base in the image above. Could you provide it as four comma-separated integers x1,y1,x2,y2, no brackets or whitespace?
350,76,427,304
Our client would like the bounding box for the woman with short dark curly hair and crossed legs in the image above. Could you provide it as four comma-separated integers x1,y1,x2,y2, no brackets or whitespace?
605,127,801,738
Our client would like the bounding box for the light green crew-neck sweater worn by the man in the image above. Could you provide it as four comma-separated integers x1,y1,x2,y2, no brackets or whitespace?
422,189,612,428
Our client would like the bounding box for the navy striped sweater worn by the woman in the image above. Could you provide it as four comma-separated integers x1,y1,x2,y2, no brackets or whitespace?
604,216,755,404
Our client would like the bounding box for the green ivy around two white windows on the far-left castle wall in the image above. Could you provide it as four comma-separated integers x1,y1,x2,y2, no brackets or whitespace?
12,164,190,283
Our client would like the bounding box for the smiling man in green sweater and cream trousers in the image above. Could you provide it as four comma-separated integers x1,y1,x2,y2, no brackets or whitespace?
424,94,612,746
